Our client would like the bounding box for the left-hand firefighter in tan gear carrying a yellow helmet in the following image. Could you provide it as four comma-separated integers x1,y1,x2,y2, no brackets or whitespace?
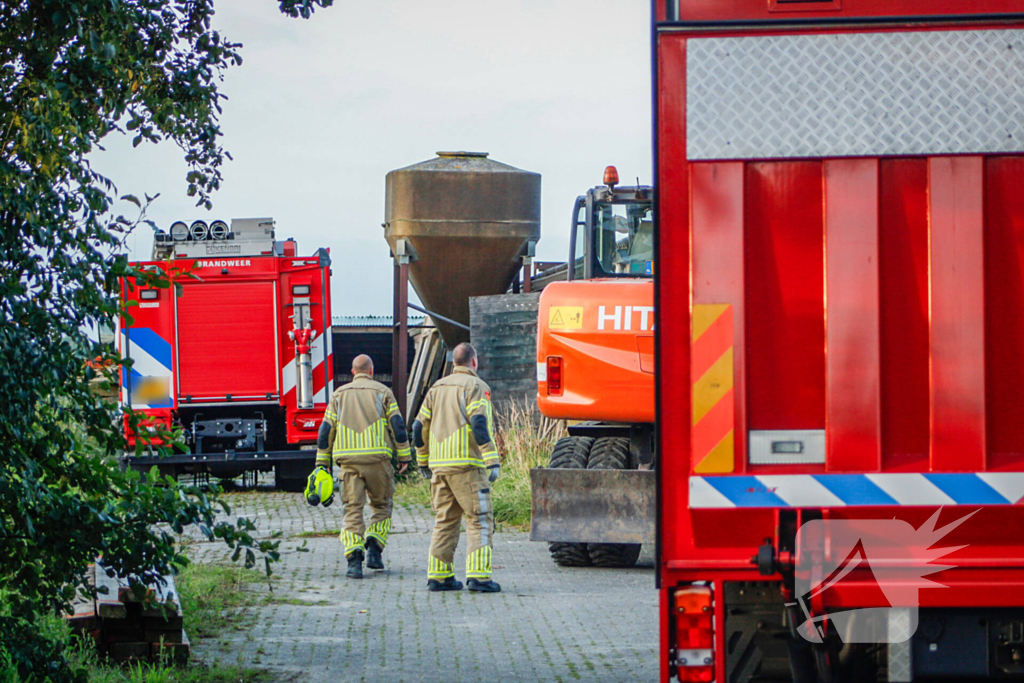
316,355,413,579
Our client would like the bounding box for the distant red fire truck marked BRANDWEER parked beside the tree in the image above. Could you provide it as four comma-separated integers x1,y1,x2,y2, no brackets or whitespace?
118,218,333,489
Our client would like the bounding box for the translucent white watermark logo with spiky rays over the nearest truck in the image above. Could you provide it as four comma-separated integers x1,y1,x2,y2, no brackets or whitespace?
791,509,978,643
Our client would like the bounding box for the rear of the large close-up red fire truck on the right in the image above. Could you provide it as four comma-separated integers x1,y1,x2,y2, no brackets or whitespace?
654,0,1024,683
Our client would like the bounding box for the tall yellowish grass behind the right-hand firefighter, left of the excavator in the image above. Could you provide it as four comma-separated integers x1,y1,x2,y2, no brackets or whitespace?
395,403,567,530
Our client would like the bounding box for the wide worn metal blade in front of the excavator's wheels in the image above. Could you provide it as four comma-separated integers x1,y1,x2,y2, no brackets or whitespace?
529,468,655,543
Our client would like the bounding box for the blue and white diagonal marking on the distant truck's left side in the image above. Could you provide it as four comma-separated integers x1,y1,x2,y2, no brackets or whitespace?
121,328,174,410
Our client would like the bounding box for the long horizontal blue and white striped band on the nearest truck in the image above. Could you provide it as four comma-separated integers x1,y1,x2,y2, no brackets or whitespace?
690,472,1024,509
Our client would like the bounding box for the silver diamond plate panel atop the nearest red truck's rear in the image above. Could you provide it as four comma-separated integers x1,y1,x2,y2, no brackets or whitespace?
686,30,1024,160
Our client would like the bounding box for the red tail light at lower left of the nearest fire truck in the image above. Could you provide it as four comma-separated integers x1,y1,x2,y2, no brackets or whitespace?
673,586,715,682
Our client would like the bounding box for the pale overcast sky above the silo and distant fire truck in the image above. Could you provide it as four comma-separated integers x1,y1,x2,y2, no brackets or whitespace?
94,0,652,315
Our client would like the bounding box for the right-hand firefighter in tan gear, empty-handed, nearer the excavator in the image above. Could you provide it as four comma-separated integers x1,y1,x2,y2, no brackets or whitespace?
413,343,502,593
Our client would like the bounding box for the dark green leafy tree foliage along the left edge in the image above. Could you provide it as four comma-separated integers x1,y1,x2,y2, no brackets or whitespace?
0,0,332,681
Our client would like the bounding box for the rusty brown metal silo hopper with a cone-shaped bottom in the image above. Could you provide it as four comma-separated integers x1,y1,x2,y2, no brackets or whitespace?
384,152,541,349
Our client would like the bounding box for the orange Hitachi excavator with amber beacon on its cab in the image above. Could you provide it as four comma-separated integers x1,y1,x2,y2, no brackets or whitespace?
530,166,654,566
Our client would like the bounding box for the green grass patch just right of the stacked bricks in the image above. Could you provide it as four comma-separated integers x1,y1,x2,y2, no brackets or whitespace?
175,562,268,638
